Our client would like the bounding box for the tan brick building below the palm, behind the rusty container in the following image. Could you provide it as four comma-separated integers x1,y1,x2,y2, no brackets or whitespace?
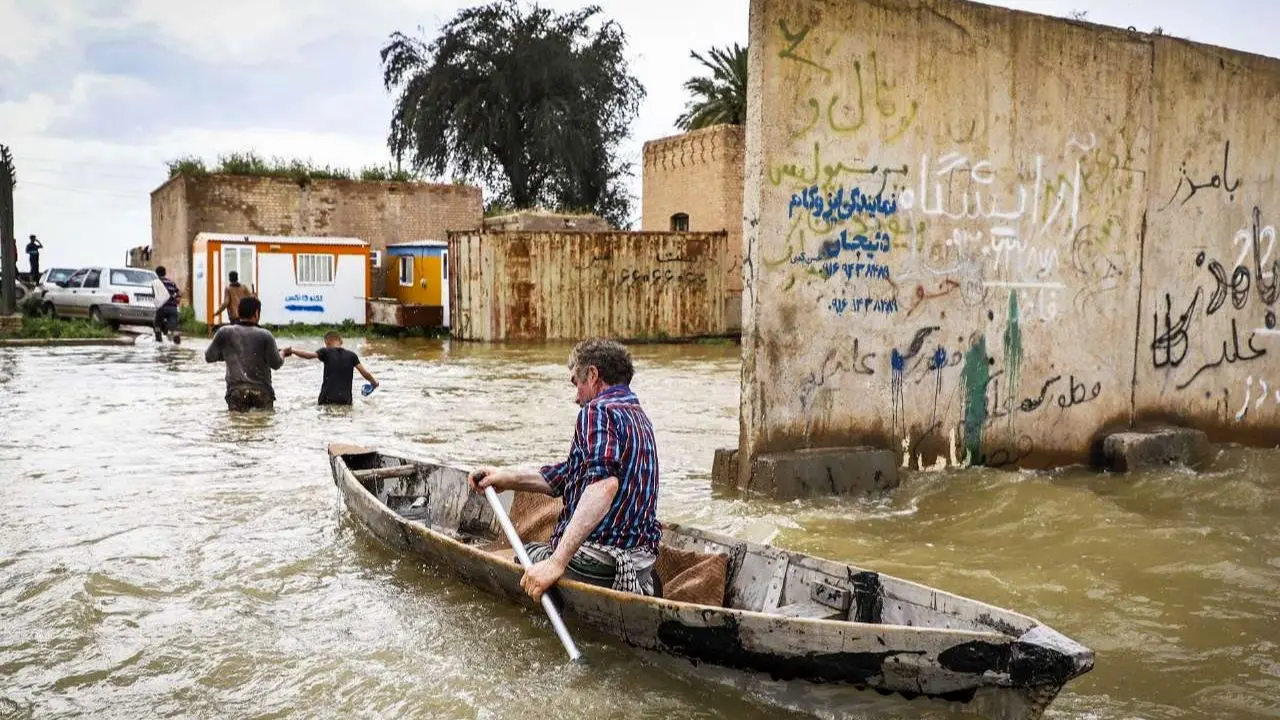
640,126,745,329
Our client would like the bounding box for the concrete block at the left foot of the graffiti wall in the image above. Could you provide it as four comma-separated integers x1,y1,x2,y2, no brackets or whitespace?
745,447,899,500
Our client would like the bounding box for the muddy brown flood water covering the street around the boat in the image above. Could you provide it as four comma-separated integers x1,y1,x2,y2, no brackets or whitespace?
0,338,1280,720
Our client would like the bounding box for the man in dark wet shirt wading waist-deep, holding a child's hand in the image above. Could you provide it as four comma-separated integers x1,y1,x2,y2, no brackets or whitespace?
205,297,284,413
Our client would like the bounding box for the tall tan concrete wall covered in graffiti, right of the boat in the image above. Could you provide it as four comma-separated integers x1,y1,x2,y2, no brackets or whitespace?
740,0,1280,473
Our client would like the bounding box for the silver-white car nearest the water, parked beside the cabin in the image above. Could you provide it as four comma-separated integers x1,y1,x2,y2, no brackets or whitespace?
40,266,156,328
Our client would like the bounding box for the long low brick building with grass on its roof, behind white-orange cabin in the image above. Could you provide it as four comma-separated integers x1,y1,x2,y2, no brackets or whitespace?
151,174,484,302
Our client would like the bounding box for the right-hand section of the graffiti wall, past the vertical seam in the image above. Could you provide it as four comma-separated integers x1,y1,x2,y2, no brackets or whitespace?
1134,40,1280,446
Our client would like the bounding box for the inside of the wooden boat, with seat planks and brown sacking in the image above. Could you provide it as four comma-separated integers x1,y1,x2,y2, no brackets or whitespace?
339,451,1037,638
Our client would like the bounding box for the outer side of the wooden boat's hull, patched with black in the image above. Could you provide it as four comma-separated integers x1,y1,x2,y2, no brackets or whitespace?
330,445,1092,720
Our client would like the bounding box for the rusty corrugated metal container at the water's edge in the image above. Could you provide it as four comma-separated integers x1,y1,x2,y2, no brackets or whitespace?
449,232,728,342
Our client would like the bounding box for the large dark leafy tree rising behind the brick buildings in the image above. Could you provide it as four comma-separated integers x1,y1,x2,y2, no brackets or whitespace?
381,0,644,227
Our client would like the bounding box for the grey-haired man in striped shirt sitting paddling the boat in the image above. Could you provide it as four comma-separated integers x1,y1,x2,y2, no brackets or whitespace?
470,340,662,601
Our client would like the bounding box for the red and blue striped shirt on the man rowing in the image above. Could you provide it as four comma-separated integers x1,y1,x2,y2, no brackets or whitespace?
541,386,662,553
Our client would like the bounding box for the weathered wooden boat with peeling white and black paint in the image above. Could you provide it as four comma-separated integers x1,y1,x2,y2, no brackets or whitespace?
329,445,1093,720
